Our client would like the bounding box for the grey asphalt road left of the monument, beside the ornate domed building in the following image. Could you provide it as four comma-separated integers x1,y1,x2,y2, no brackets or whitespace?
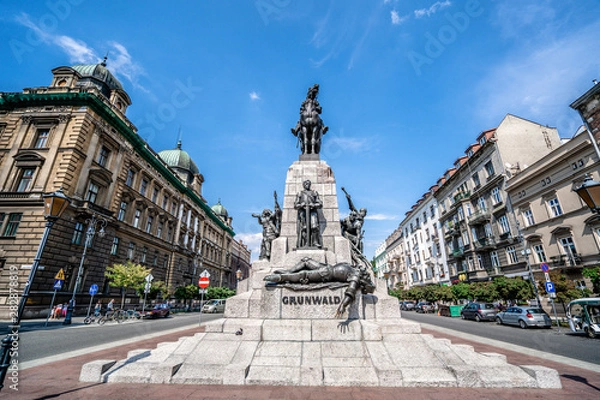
19,313,223,363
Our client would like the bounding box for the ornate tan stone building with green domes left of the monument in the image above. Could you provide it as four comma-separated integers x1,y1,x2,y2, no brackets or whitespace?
0,59,250,318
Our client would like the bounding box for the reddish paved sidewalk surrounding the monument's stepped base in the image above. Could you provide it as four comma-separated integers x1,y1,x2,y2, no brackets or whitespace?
0,327,600,400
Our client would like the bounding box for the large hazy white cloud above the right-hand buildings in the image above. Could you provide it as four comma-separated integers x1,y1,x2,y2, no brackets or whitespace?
475,22,600,137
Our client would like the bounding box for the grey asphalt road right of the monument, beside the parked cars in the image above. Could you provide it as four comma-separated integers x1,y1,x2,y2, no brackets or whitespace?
402,311,600,365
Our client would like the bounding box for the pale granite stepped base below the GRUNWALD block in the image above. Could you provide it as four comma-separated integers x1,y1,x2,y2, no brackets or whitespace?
80,318,561,389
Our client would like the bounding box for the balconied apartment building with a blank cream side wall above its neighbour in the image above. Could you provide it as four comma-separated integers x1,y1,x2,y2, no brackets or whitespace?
434,114,561,282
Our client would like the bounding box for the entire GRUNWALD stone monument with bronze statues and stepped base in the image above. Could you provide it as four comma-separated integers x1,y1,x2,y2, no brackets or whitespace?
80,85,561,388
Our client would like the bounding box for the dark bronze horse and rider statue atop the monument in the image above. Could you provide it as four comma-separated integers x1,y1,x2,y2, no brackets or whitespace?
292,84,329,154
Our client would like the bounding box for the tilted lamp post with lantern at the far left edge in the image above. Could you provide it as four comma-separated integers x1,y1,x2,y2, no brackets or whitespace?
0,188,71,389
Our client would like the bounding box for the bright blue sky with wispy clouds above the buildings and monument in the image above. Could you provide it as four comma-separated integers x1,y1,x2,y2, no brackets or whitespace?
0,0,600,258
